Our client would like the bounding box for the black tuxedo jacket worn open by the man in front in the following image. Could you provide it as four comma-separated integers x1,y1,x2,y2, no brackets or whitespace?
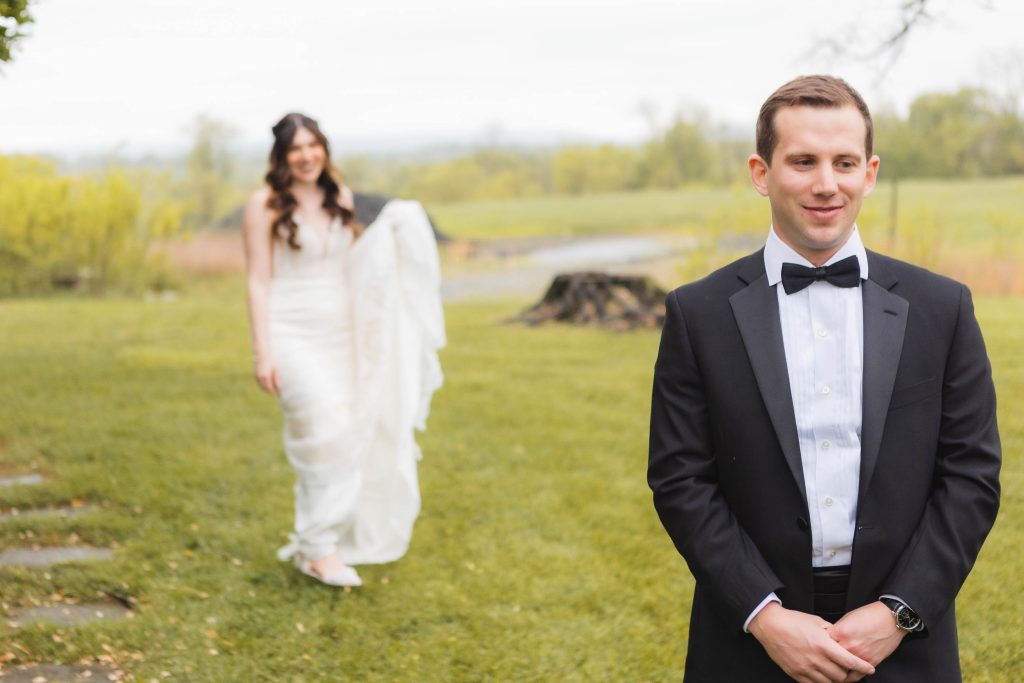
648,252,1000,683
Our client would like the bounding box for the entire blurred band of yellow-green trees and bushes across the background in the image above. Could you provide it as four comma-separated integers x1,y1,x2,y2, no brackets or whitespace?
0,83,1024,296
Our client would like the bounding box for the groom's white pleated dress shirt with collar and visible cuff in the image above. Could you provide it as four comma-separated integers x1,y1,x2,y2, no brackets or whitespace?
743,227,867,631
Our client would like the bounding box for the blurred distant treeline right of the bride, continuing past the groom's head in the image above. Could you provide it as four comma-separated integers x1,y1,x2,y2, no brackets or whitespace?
339,88,1024,202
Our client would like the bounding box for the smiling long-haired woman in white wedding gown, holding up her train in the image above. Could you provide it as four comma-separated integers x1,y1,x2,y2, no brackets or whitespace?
244,114,445,586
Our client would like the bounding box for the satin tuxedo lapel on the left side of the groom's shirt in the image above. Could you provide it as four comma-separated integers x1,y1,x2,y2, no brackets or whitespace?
729,251,807,502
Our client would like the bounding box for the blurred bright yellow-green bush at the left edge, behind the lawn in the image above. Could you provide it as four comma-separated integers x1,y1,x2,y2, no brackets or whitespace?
0,157,180,296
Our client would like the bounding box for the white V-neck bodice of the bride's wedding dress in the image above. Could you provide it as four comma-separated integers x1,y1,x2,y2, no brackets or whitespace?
272,217,352,281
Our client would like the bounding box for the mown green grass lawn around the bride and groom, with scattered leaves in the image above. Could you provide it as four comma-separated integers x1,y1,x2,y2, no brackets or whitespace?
0,280,1024,682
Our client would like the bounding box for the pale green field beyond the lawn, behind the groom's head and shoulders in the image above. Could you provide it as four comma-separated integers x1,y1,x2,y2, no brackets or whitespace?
428,175,1024,296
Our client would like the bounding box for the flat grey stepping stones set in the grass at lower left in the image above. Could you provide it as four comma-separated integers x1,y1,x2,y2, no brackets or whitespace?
0,472,132,683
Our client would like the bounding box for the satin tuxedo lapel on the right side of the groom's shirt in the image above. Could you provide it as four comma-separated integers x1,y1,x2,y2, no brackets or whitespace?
858,259,910,500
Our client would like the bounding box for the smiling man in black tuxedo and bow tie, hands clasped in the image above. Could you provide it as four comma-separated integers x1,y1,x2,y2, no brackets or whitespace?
648,76,1000,683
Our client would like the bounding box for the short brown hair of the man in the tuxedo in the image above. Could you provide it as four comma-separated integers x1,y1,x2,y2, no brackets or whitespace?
756,76,874,166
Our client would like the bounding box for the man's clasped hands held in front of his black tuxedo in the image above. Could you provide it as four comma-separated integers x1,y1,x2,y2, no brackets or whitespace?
750,602,904,683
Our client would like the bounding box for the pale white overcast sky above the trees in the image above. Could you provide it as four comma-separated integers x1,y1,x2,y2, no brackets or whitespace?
0,0,1024,155
